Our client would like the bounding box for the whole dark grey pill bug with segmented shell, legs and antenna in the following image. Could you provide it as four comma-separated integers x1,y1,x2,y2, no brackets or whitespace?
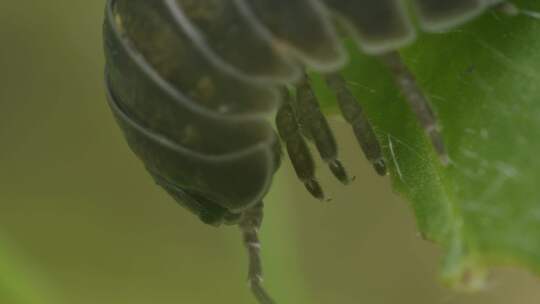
104,0,513,303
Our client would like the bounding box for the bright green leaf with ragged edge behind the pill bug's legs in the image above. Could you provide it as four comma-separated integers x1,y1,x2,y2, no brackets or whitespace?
315,0,540,288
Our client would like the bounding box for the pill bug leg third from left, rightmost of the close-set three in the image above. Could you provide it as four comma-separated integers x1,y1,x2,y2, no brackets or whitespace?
325,73,387,175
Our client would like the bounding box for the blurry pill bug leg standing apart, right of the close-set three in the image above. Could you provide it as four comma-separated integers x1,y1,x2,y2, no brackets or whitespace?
379,52,450,165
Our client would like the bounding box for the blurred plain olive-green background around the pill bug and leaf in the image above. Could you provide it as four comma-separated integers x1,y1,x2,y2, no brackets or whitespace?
0,0,540,304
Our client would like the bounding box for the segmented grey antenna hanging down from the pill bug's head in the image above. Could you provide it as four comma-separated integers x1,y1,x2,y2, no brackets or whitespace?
238,202,275,304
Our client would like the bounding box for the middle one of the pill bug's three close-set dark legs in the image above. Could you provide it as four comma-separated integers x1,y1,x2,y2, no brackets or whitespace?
296,75,350,184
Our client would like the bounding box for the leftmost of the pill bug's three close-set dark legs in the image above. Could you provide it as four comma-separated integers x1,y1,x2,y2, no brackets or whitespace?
276,88,324,200
